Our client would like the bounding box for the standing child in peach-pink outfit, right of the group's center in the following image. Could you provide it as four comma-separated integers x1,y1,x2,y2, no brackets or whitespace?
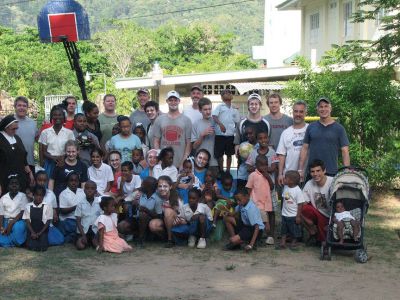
246,155,275,245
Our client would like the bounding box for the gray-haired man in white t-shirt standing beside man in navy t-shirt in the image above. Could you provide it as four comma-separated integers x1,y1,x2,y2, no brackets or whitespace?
276,100,308,185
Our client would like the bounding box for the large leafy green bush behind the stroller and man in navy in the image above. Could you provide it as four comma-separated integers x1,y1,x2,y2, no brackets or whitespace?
285,59,400,185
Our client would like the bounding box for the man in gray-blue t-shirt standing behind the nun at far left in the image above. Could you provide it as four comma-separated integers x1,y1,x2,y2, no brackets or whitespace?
14,96,38,172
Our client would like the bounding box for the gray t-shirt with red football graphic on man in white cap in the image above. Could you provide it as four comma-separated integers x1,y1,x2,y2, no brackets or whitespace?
153,114,192,167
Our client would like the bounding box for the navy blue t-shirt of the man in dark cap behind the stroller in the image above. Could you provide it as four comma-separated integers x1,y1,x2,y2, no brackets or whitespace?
304,121,349,175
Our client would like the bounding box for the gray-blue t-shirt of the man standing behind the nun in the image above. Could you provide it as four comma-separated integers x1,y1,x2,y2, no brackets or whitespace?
15,116,38,166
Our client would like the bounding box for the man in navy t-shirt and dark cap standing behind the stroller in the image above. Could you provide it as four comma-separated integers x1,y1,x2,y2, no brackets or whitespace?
299,97,350,179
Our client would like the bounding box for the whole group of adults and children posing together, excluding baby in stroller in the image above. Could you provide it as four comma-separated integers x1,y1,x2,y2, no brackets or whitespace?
0,86,350,253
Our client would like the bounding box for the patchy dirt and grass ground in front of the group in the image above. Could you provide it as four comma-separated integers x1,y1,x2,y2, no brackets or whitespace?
0,193,400,299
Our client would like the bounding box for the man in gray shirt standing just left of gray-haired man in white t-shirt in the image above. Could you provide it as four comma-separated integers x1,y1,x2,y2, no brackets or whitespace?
264,94,293,151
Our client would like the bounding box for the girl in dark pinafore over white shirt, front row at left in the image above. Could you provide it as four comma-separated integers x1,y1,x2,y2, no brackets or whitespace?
22,185,53,251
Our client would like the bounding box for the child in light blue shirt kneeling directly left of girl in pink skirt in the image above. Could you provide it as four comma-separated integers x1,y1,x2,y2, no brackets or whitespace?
75,180,102,250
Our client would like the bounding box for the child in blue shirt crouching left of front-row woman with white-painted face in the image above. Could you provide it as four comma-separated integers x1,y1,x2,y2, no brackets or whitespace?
138,177,162,247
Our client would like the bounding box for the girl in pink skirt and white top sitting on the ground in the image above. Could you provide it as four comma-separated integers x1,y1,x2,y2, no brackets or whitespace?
95,196,132,253
